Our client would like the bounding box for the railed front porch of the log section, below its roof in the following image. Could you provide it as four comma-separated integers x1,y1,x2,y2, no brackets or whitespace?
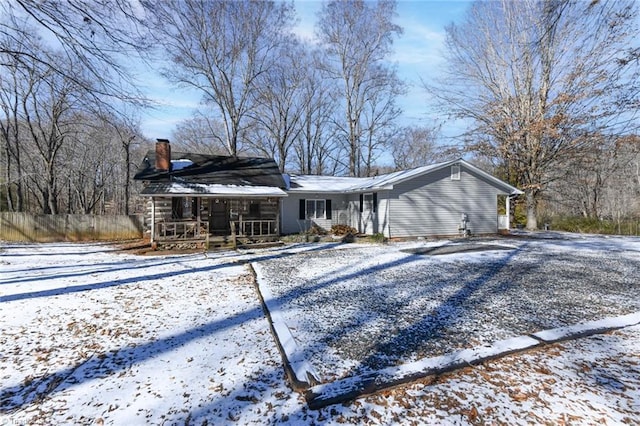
148,196,280,247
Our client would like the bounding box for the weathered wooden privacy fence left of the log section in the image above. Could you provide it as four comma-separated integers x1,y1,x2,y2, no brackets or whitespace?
0,213,144,242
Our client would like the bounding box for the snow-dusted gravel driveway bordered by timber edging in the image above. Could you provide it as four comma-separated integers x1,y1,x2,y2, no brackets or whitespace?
254,234,640,380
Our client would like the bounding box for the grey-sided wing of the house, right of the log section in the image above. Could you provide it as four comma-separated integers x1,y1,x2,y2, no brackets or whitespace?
282,159,522,238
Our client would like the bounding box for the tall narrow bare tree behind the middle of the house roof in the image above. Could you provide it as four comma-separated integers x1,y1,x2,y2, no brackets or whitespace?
317,0,402,176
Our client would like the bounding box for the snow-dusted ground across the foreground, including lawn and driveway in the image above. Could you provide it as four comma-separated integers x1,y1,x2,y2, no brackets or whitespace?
0,237,640,424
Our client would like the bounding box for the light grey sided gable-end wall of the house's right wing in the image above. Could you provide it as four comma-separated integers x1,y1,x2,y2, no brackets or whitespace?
389,166,503,237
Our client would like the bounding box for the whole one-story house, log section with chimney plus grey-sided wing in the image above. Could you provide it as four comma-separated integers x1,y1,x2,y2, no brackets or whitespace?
134,139,522,243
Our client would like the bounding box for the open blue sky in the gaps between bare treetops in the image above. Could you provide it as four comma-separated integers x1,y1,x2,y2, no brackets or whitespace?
141,0,469,139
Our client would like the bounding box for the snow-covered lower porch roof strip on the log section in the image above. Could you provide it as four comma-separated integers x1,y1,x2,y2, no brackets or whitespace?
140,181,287,198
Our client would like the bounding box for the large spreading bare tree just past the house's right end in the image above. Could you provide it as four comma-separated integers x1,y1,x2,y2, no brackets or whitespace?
427,0,640,229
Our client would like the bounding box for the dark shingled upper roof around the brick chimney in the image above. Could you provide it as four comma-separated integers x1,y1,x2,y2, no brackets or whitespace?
134,150,286,189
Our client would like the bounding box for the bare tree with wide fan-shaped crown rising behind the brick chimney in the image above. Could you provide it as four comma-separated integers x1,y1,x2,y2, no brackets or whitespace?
144,0,293,155
